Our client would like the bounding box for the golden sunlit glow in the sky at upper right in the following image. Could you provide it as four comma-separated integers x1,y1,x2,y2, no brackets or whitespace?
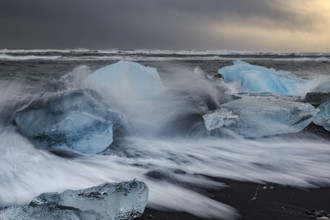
211,0,330,52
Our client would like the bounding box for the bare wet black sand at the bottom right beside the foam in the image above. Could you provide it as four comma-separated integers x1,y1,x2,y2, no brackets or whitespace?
139,124,330,220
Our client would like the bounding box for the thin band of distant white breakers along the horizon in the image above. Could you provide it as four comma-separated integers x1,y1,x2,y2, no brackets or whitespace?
0,48,330,62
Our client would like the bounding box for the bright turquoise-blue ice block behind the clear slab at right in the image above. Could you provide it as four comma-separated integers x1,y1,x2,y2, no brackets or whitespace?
219,60,306,96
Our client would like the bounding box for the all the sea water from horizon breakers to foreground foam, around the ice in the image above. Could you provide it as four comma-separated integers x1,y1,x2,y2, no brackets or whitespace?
0,49,330,219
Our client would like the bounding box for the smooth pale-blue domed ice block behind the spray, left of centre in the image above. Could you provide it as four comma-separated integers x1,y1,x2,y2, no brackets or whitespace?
84,61,163,102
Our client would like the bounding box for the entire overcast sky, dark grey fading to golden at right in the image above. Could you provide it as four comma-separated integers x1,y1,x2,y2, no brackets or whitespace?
0,0,330,52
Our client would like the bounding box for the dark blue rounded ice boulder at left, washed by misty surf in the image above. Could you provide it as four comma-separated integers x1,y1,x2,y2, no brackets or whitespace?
15,90,122,154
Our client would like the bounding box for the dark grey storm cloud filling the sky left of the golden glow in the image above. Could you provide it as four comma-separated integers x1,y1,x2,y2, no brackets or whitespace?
0,0,324,49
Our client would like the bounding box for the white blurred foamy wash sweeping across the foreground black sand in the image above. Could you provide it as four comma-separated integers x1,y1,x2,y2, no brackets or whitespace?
0,129,330,218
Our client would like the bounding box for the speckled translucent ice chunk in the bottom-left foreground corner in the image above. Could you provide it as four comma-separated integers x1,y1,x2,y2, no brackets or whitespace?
0,180,148,220
